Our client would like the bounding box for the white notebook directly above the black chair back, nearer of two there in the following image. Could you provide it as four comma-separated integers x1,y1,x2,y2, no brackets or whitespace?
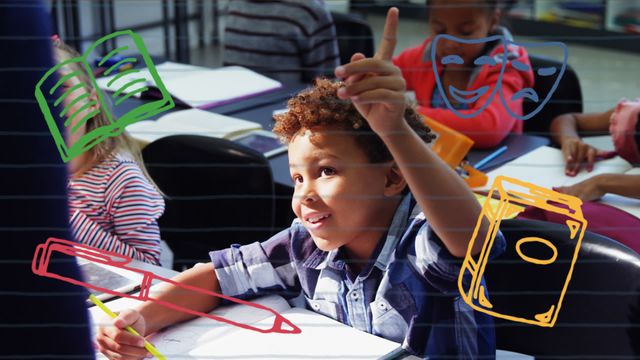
127,109,262,143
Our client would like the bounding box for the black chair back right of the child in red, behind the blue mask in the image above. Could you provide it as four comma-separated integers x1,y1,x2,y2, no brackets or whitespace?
522,54,582,137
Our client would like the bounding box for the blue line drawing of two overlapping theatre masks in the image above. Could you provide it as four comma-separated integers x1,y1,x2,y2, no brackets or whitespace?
431,34,568,120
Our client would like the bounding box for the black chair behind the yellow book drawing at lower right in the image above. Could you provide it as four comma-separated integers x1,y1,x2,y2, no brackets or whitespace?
485,219,640,359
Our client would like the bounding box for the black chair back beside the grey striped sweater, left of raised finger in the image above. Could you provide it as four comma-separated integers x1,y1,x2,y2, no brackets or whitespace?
331,12,374,64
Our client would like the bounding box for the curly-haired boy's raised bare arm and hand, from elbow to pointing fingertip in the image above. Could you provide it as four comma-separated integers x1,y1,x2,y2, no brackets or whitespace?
336,8,487,257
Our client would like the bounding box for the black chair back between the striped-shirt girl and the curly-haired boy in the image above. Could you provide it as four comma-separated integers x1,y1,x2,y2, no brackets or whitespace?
142,135,274,270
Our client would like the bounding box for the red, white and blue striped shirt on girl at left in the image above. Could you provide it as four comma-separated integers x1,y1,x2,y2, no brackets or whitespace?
68,155,164,265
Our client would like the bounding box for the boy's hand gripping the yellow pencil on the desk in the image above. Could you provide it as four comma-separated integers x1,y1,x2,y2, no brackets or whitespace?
96,310,149,359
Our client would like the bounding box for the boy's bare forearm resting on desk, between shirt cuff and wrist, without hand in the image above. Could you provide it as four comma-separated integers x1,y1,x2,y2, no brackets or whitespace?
139,264,220,334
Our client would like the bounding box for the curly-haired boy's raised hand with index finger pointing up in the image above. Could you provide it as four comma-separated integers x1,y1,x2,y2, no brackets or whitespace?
335,7,406,134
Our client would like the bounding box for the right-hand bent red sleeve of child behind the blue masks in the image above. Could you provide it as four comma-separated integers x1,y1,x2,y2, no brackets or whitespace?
418,56,533,148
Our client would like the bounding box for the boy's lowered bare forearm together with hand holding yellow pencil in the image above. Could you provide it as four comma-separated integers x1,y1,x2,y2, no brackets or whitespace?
96,264,220,359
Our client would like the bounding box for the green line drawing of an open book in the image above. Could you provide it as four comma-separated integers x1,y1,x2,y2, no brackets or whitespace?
35,30,174,162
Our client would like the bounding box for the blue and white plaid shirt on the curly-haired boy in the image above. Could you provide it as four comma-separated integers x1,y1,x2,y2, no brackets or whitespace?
210,195,505,359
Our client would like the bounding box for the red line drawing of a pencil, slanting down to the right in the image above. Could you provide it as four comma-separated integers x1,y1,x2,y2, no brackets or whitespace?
31,238,301,334
